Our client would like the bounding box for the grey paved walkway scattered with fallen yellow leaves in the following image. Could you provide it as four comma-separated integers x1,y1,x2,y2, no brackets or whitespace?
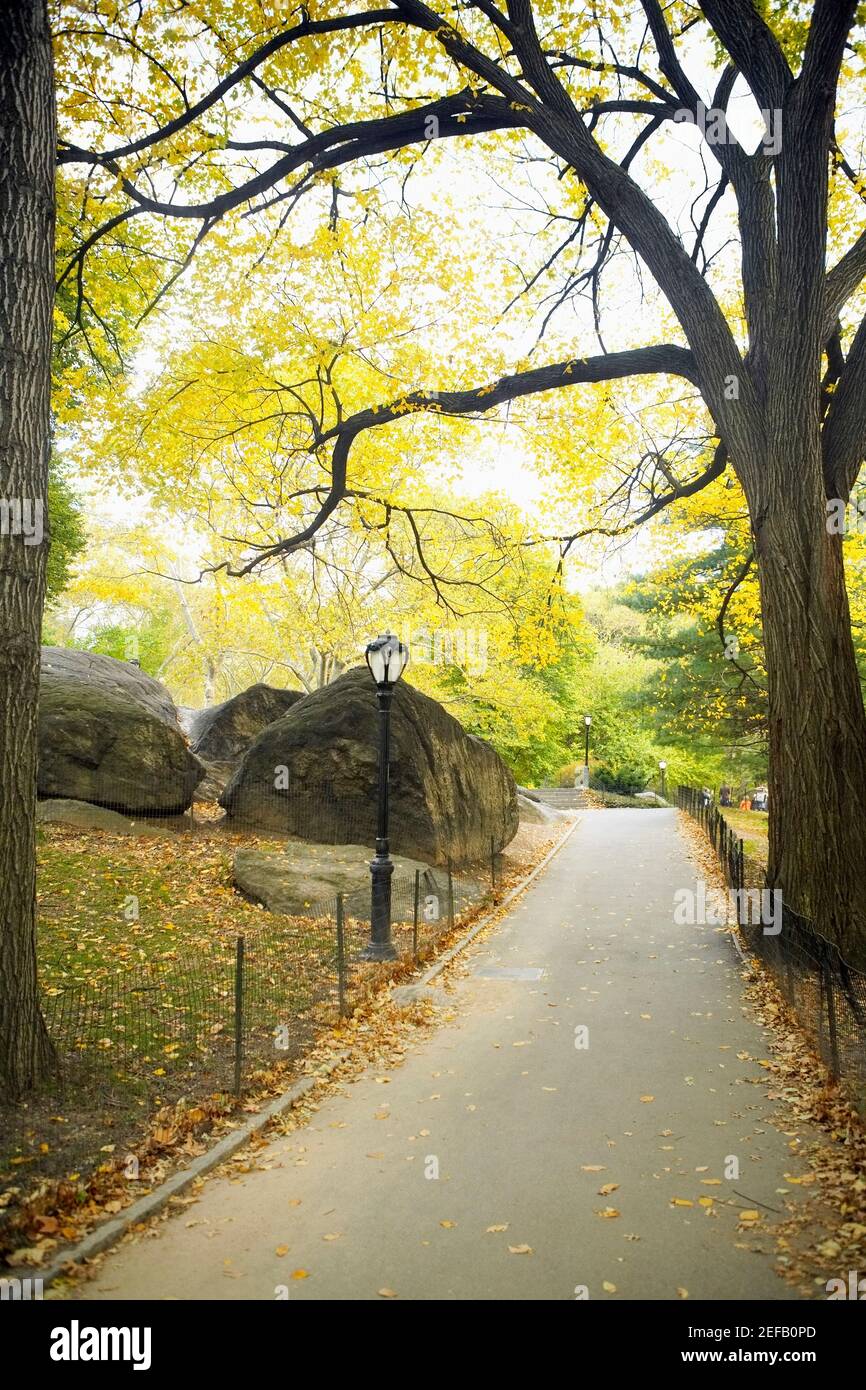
72,810,799,1300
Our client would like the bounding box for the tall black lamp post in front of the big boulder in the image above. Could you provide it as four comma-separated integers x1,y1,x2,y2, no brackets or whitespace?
361,632,409,960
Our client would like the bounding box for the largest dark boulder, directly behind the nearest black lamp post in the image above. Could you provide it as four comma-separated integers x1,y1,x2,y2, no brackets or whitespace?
220,667,517,865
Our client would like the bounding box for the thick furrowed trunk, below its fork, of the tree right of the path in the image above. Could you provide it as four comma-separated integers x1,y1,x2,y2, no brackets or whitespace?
756,455,866,966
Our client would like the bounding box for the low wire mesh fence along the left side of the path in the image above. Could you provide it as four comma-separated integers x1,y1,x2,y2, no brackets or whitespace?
43,855,499,1094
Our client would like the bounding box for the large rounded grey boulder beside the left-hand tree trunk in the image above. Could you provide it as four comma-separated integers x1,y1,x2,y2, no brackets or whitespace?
39,646,204,816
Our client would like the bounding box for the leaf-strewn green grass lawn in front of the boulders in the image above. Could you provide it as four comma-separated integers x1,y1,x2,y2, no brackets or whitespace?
38,826,383,1084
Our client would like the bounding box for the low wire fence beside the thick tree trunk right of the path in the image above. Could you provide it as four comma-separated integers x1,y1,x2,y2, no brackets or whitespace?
677,787,866,1113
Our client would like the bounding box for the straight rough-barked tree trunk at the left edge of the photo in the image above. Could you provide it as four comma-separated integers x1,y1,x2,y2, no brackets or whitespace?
0,0,54,1097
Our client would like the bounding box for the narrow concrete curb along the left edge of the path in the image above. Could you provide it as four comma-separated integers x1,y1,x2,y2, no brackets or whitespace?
35,820,580,1289
